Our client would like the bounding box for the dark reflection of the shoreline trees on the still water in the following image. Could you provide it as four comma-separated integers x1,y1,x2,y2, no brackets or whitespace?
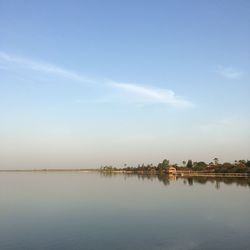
100,172,250,189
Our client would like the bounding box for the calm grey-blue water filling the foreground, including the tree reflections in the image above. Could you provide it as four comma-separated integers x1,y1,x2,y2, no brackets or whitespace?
0,173,250,250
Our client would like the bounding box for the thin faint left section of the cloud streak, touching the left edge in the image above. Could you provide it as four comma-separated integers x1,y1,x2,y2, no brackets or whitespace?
0,52,94,83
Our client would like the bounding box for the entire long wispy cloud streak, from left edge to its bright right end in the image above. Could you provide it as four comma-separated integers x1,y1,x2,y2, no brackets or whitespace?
0,51,193,108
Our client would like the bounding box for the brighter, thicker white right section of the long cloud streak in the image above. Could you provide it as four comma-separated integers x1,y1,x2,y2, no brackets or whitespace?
109,81,193,108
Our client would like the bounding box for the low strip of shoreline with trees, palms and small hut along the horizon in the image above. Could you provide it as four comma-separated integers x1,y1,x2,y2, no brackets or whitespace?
0,158,250,177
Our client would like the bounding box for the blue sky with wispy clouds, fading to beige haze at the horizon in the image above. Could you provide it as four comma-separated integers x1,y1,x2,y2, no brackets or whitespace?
0,0,250,169
